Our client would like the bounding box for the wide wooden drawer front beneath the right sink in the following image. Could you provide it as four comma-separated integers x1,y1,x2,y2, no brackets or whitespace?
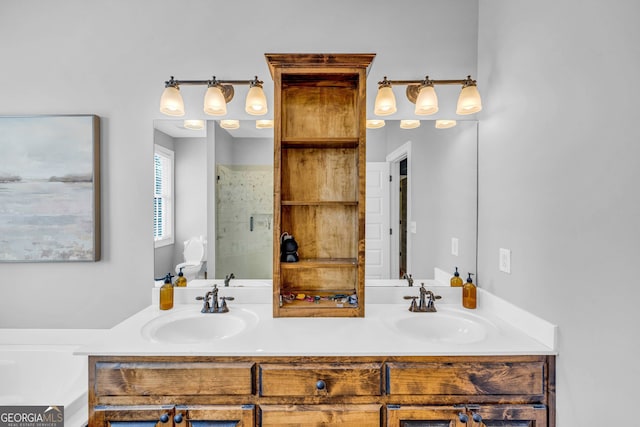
387,362,545,396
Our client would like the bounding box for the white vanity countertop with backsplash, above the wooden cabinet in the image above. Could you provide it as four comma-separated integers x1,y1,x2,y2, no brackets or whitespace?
76,282,557,356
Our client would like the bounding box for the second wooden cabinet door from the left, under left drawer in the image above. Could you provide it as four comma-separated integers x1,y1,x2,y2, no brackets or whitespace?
174,405,255,427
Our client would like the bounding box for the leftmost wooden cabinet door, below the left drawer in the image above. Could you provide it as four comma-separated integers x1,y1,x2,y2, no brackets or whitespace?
89,405,174,427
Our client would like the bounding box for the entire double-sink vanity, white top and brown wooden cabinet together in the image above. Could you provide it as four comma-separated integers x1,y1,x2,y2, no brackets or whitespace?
79,280,556,427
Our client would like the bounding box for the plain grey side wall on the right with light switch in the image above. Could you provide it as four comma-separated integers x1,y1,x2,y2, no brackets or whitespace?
478,0,640,427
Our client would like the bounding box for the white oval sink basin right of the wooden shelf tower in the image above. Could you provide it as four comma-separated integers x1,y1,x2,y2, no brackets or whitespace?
393,308,495,344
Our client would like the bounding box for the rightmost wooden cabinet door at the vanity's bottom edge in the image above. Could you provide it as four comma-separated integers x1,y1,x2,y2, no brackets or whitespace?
467,405,547,427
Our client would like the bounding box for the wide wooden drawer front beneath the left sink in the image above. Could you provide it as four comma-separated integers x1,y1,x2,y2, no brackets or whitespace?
95,362,254,396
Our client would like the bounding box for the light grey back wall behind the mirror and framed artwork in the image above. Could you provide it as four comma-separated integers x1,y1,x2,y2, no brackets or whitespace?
0,0,478,328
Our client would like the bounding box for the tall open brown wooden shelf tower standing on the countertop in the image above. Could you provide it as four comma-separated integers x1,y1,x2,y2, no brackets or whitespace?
265,54,375,317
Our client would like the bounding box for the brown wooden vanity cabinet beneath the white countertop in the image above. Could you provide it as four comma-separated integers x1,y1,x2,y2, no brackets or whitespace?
89,356,555,427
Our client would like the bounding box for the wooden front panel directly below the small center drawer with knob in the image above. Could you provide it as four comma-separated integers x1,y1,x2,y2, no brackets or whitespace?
260,405,382,427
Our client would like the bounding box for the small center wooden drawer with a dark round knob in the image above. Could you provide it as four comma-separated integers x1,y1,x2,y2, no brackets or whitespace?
259,363,382,396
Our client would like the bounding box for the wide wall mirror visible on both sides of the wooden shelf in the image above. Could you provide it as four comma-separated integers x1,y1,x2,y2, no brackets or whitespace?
154,119,478,280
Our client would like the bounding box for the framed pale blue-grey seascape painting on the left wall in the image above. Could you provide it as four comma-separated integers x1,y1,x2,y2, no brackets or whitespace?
0,115,100,262
